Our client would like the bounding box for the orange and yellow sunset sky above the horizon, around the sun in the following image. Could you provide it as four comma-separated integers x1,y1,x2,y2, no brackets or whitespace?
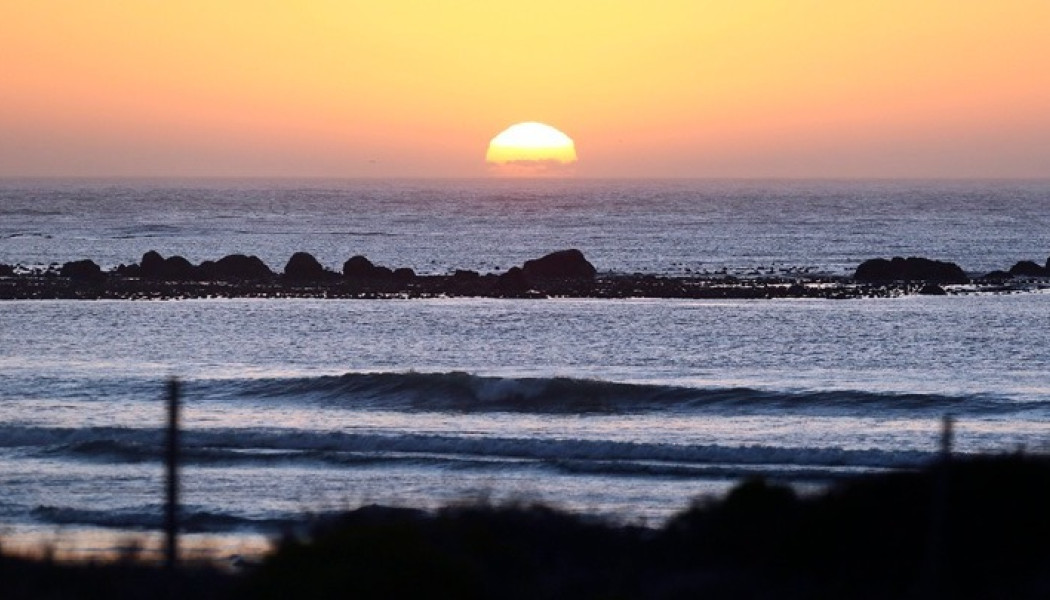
0,0,1050,178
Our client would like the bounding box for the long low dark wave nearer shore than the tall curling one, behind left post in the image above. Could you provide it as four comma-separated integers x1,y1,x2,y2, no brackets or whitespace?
0,426,935,476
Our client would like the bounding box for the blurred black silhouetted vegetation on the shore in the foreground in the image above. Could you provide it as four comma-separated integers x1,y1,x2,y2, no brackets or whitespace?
6,456,1050,600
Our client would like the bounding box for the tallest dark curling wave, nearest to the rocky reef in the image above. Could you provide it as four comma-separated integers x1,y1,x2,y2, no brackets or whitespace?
200,372,1024,414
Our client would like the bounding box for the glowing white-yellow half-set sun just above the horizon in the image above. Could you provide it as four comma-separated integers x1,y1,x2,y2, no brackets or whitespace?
485,121,576,175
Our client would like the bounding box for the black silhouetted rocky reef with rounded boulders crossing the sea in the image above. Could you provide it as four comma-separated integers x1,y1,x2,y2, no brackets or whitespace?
0,249,1050,299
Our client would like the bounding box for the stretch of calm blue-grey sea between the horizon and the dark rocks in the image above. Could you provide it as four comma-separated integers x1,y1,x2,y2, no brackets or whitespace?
6,180,1050,274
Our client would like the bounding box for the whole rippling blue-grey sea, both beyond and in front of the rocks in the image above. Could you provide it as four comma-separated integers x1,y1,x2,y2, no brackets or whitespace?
0,180,1050,553
